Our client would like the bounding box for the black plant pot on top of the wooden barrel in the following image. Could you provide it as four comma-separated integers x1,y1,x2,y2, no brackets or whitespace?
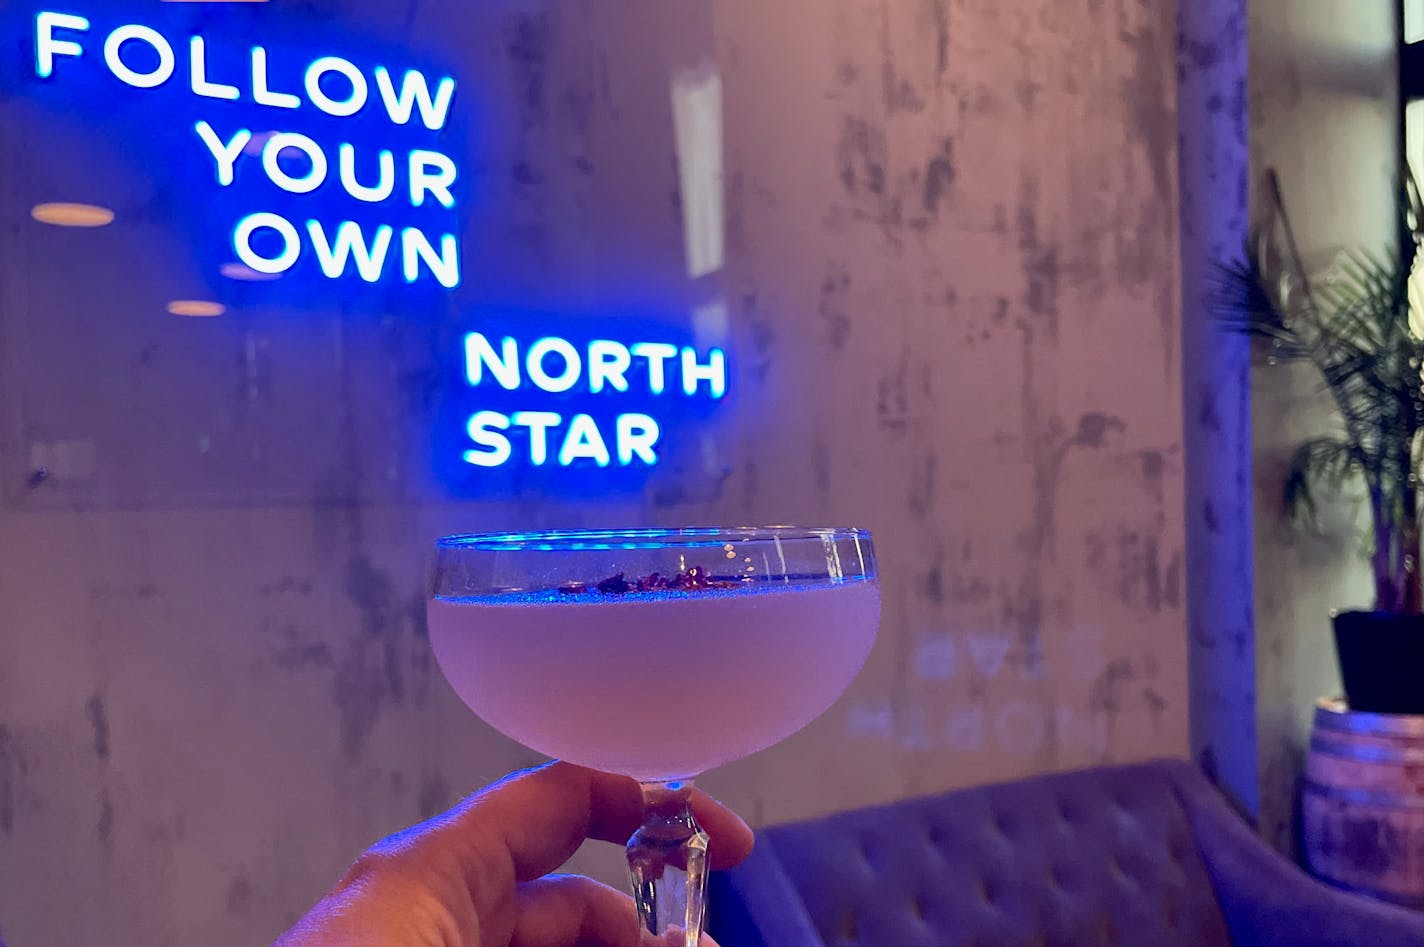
1334,611,1424,713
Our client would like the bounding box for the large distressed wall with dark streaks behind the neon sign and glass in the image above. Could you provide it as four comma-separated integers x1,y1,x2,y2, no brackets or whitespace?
0,0,1188,947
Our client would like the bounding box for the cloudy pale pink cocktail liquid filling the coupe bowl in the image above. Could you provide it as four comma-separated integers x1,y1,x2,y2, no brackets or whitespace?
429,580,880,780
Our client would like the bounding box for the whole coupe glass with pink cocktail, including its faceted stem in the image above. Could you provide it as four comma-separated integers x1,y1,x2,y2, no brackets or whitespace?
429,527,880,947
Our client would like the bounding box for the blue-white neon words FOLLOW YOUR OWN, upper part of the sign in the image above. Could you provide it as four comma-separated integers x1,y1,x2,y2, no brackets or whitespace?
34,11,461,289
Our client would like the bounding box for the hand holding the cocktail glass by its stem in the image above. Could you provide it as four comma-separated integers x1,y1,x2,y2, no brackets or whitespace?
273,763,752,947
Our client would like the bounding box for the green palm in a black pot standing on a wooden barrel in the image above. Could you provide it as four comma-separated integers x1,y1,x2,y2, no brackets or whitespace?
1215,175,1424,713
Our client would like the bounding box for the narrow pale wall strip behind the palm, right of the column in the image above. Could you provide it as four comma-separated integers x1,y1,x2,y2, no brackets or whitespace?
1250,0,1398,849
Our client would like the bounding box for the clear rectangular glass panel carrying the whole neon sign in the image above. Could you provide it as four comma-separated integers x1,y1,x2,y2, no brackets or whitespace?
0,0,735,506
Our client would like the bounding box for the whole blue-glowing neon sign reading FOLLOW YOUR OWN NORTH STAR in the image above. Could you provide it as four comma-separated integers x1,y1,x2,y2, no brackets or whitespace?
16,7,736,484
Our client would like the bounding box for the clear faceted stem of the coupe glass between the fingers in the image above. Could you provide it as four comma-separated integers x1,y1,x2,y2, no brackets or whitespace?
628,780,708,947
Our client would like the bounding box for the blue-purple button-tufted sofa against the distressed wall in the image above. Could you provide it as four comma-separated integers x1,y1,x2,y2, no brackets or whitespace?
709,760,1424,947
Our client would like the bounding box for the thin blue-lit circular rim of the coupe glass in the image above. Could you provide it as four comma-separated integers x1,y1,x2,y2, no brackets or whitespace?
436,525,870,553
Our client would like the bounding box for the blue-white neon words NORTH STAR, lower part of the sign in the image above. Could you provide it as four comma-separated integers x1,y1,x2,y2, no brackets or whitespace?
463,332,728,467
